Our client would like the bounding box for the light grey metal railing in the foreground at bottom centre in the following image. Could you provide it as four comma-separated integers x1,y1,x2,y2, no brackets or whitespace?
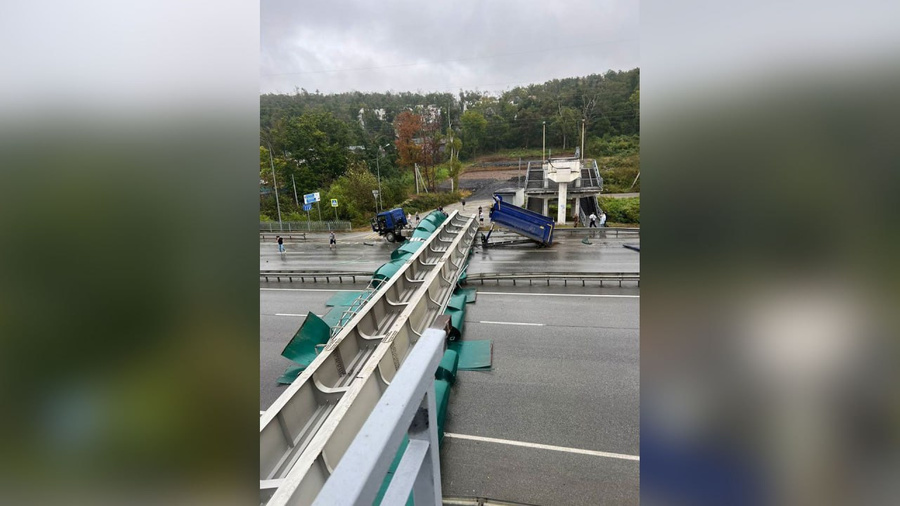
313,328,447,506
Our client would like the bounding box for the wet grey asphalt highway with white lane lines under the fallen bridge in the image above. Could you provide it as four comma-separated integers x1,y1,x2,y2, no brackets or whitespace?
260,233,640,505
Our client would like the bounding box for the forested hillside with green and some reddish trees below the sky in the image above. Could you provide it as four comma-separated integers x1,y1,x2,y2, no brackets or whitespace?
260,69,640,221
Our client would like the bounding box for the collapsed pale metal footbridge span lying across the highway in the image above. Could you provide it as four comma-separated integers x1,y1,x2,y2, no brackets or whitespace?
259,211,477,506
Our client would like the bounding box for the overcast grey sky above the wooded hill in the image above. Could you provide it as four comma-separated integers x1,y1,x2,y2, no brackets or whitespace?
260,0,640,93
